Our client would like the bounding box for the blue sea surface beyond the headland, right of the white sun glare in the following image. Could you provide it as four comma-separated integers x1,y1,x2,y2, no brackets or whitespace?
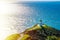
18,2,60,30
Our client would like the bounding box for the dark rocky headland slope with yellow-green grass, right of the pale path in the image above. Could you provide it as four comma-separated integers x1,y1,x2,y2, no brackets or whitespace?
21,24,60,40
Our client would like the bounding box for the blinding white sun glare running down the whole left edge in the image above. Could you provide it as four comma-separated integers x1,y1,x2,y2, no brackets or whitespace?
0,1,17,40
